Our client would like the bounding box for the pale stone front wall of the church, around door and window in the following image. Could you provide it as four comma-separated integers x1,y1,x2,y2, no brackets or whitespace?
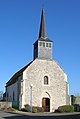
23,59,68,112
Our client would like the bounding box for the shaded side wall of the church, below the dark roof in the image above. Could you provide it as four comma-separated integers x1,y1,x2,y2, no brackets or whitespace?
6,76,22,108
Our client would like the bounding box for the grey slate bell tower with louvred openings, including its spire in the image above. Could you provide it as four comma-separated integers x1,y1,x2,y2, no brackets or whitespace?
34,9,52,60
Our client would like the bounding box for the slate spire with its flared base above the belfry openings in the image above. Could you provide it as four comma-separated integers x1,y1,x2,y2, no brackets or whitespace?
38,9,52,42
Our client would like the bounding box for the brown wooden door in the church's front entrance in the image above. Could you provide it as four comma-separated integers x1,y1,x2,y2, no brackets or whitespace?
42,98,50,112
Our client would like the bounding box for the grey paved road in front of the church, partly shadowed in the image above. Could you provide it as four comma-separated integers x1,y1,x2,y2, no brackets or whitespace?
0,112,80,119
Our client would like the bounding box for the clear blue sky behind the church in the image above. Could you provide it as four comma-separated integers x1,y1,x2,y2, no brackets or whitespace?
0,0,80,95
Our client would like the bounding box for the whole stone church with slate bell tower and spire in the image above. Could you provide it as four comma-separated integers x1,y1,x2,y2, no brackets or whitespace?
6,9,70,112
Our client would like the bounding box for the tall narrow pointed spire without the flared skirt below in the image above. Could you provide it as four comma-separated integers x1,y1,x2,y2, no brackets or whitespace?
39,8,47,39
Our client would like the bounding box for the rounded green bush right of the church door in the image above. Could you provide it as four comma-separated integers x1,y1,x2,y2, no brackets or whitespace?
57,105,74,113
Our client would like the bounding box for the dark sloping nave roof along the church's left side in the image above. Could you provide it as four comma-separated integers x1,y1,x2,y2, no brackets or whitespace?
6,61,33,86
